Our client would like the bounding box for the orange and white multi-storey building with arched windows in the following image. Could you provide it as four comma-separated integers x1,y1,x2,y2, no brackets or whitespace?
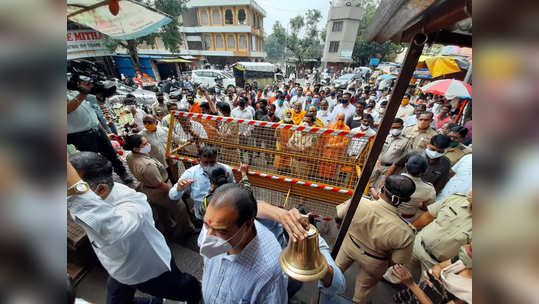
180,0,266,65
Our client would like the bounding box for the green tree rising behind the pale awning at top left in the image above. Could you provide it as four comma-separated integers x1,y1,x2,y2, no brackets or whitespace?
105,0,186,72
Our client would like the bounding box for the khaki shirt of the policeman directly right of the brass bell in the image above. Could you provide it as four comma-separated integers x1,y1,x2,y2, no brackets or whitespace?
348,199,415,264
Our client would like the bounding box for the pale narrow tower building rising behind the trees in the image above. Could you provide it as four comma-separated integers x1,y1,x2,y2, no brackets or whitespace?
322,0,363,68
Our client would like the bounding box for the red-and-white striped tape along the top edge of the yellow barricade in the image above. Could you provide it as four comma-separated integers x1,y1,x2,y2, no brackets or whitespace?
172,111,368,138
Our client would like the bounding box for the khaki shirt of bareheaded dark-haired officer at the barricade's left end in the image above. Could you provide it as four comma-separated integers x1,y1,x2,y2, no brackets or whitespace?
127,152,168,188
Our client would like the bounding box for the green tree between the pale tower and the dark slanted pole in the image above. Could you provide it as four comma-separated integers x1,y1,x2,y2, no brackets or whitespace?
352,1,402,66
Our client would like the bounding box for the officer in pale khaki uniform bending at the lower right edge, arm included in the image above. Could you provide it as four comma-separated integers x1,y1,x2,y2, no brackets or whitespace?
409,190,472,278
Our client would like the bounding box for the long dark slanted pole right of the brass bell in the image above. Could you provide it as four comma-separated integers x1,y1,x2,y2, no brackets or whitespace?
331,34,425,258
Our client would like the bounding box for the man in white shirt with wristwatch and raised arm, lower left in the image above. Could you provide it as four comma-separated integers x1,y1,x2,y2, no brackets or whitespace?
67,152,202,304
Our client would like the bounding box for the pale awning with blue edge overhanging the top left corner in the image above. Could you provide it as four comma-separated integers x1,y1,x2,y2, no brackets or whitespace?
67,0,172,40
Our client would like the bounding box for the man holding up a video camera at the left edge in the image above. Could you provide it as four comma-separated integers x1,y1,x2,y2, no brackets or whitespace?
67,75,133,184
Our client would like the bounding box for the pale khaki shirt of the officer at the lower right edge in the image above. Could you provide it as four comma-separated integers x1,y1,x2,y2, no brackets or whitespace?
417,193,472,261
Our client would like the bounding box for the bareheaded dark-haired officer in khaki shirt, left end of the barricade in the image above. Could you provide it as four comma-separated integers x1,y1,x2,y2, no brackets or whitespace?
124,135,195,239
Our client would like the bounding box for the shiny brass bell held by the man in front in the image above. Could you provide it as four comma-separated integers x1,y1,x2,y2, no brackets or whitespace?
279,225,328,282
